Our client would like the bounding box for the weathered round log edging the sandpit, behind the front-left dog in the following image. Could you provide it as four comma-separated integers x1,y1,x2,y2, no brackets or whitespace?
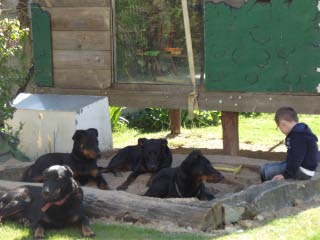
0,180,223,230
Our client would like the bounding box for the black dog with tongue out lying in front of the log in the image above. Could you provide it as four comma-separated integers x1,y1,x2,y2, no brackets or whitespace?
0,165,95,239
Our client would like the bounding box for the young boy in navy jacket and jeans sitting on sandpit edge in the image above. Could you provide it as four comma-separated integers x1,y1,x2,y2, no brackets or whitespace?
260,107,318,182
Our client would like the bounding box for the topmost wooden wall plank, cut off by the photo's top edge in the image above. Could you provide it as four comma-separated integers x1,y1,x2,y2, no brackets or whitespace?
34,0,111,7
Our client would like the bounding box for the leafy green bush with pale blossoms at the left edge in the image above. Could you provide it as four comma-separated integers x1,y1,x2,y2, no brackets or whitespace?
0,18,28,160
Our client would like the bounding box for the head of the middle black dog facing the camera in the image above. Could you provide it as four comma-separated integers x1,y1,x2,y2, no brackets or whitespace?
138,138,168,172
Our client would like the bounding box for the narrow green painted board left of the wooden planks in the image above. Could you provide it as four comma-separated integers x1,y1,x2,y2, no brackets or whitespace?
31,3,53,87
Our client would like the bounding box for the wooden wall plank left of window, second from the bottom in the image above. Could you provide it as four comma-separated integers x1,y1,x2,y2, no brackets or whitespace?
53,50,112,70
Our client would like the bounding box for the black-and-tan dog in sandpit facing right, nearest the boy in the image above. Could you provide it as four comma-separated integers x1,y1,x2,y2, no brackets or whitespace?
144,150,223,200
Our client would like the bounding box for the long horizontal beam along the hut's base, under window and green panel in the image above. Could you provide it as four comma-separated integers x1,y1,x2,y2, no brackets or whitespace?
32,88,320,114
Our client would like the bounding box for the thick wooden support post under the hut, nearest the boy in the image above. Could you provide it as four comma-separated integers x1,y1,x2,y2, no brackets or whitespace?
221,112,239,156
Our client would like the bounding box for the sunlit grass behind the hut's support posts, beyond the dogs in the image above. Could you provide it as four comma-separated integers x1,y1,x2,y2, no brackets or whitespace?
113,114,320,150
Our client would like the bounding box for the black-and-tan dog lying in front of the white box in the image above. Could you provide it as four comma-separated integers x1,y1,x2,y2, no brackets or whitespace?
22,128,109,189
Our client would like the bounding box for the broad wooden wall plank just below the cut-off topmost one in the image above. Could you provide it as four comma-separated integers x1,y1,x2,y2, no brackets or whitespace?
46,7,111,31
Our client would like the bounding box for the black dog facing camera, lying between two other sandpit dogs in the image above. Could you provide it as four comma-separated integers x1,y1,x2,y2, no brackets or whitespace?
103,138,172,190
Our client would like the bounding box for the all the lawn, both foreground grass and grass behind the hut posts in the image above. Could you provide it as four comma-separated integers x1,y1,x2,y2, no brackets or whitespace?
0,114,320,240
